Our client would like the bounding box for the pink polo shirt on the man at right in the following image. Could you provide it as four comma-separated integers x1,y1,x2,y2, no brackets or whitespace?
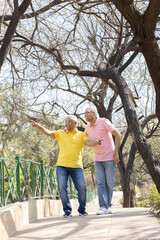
85,118,115,161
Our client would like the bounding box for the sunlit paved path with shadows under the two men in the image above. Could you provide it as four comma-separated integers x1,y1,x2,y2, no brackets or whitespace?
9,193,160,240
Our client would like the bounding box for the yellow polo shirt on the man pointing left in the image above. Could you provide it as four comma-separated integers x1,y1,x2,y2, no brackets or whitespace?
54,129,88,168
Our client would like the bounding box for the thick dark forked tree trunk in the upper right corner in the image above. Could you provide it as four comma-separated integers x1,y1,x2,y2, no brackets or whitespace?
112,0,160,120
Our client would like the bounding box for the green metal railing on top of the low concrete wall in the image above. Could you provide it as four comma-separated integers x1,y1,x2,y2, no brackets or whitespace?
0,157,97,207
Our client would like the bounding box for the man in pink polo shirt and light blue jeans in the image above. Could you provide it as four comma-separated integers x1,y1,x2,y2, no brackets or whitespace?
84,107,121,215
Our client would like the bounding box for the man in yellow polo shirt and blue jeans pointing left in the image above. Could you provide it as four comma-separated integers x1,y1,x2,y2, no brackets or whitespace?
30,115,101,217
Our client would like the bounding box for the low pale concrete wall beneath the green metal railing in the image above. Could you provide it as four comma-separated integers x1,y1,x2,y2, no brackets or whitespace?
0,199,97,240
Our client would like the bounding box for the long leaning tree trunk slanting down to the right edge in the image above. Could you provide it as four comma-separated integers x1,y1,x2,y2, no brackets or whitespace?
99,66,160,193
